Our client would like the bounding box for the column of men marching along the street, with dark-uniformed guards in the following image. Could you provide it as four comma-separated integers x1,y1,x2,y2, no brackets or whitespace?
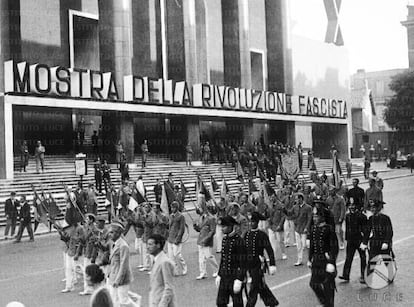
6,164,393,306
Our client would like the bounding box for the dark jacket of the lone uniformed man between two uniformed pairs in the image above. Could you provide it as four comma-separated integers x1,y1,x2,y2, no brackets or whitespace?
308,224,338,266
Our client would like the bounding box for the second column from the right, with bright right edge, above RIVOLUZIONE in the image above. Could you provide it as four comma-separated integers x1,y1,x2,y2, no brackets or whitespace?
221,0,251,88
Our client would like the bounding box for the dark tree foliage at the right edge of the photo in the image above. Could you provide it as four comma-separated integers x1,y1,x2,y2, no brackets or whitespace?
384,71,414,132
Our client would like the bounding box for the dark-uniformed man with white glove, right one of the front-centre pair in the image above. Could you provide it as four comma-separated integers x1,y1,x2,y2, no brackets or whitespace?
244,212,279,307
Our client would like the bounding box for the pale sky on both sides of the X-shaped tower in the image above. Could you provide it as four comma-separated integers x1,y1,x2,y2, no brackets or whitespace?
288,0,414,73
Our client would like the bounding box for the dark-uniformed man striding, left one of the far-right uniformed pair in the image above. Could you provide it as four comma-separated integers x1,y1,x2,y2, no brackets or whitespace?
339,203,367,284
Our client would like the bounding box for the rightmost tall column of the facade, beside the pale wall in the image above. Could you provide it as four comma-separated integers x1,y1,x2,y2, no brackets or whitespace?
265,0,292,93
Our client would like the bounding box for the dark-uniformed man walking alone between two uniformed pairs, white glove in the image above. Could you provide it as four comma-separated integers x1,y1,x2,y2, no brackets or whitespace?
308,206,338,306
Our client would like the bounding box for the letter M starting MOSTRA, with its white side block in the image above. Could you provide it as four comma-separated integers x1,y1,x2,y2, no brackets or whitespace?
4,61,30,93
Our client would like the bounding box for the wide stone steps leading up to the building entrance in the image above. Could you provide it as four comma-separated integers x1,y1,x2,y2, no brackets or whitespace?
0,155,362,226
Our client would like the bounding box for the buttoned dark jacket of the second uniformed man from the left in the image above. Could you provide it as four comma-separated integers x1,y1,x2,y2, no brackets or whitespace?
244,229,275,269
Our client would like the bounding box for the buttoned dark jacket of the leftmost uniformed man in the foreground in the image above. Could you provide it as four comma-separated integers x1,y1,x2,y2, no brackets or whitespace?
218,233,246,281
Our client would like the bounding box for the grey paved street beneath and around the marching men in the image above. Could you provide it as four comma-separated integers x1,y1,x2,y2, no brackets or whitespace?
0,177,414,307
